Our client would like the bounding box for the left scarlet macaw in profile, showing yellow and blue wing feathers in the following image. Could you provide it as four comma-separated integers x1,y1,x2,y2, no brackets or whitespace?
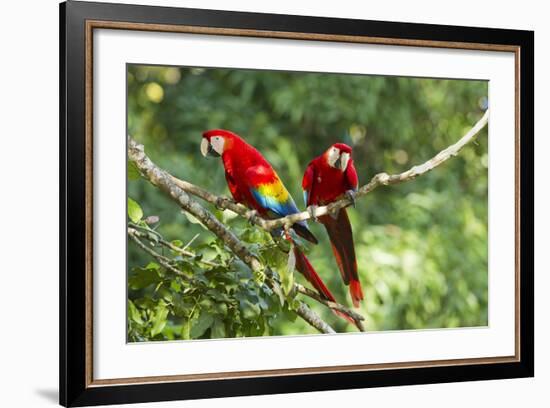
201,129,340,304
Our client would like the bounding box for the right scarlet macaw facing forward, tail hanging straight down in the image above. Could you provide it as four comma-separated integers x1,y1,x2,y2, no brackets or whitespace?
302,143,363,307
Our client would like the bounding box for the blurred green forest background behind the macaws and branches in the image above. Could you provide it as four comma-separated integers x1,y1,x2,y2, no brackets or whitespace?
128,65,488,340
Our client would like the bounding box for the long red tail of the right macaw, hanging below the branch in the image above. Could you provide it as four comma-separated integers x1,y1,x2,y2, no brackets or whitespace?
319,208,363,307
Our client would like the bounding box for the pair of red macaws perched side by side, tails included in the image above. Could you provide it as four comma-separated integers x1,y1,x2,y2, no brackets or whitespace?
201,129,363,320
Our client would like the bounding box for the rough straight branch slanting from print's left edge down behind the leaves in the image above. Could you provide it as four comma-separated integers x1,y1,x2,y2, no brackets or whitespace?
128,136,335,333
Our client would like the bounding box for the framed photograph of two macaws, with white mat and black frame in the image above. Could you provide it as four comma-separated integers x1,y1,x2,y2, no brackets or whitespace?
60,1,534,406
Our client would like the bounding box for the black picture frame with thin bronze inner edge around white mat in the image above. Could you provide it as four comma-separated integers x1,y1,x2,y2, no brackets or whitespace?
60,1,534,406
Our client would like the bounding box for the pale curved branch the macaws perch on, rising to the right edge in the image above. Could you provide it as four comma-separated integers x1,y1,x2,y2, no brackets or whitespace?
170,109,489,231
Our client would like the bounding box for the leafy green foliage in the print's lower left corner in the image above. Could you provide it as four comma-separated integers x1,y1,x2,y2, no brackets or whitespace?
128,217,302,341
